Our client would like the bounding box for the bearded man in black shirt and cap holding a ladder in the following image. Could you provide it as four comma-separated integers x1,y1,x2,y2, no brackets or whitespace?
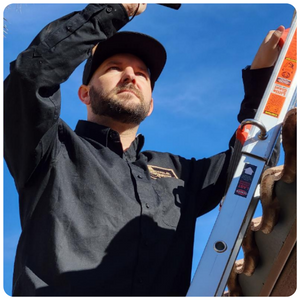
4,4,284,296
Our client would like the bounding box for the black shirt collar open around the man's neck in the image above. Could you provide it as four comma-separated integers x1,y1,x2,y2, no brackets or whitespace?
75,120,145,160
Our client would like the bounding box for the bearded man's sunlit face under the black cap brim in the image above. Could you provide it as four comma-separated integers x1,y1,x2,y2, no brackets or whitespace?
86,54,153,125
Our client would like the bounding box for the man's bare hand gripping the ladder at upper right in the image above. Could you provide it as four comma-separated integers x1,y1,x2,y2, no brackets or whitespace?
250,25,285,69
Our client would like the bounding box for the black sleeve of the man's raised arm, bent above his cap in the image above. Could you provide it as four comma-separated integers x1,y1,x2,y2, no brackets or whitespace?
4,4,128,189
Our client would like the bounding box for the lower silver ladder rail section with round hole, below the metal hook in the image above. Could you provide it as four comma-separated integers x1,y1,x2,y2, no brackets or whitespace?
187,155,265,296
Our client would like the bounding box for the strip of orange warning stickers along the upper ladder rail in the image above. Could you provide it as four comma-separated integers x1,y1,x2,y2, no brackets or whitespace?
264,30,297,118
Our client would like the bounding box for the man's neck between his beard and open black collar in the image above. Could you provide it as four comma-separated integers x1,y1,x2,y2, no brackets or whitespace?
88,116,139,151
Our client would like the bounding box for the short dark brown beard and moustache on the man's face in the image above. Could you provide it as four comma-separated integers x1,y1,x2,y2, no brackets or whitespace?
90,83,150,125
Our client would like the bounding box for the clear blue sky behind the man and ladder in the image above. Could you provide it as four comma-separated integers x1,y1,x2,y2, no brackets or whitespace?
3,1,294,294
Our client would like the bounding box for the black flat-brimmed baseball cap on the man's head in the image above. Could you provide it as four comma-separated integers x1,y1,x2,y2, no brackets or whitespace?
82,31,167,89
